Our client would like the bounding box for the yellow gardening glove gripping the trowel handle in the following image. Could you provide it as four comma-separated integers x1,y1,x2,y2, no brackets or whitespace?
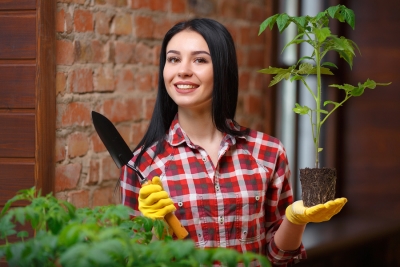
139,176,176,219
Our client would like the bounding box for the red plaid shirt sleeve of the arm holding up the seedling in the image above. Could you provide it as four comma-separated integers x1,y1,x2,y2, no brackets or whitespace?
266,143,307,266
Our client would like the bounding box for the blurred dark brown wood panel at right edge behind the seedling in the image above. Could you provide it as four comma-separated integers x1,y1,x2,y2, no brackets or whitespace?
338,0,400,220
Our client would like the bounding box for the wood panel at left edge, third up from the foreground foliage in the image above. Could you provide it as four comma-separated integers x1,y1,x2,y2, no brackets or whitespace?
0,65,36,109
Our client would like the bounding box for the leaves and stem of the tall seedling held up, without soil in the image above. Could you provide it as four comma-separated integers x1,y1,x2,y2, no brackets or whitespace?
259,5,390,168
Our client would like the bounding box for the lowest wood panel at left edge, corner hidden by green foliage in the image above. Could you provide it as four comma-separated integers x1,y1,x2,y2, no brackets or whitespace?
0,161,35,206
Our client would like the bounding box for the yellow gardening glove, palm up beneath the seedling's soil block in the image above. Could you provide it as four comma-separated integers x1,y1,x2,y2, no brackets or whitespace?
286,197,347,225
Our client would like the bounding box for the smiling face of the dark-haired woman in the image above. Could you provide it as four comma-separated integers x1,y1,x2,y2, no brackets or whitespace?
163,30,214,111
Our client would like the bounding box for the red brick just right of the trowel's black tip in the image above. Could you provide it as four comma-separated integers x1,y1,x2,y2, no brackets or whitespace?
103,98,143,123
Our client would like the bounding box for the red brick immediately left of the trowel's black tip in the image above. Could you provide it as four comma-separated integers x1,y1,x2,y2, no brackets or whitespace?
61,102,92,127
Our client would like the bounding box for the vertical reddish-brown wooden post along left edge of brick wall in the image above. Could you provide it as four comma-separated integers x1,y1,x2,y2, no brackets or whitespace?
35,0,56,197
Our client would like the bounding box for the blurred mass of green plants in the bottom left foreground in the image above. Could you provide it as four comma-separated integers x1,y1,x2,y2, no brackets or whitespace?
0,188,271,267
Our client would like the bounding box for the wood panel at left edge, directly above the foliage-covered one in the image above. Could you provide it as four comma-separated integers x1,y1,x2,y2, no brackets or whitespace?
0,113,35,158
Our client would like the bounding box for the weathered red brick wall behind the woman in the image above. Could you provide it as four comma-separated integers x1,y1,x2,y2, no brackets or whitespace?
55,0,271,207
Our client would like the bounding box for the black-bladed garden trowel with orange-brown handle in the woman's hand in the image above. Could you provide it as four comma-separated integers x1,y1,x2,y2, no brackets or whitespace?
92,111,188,239
